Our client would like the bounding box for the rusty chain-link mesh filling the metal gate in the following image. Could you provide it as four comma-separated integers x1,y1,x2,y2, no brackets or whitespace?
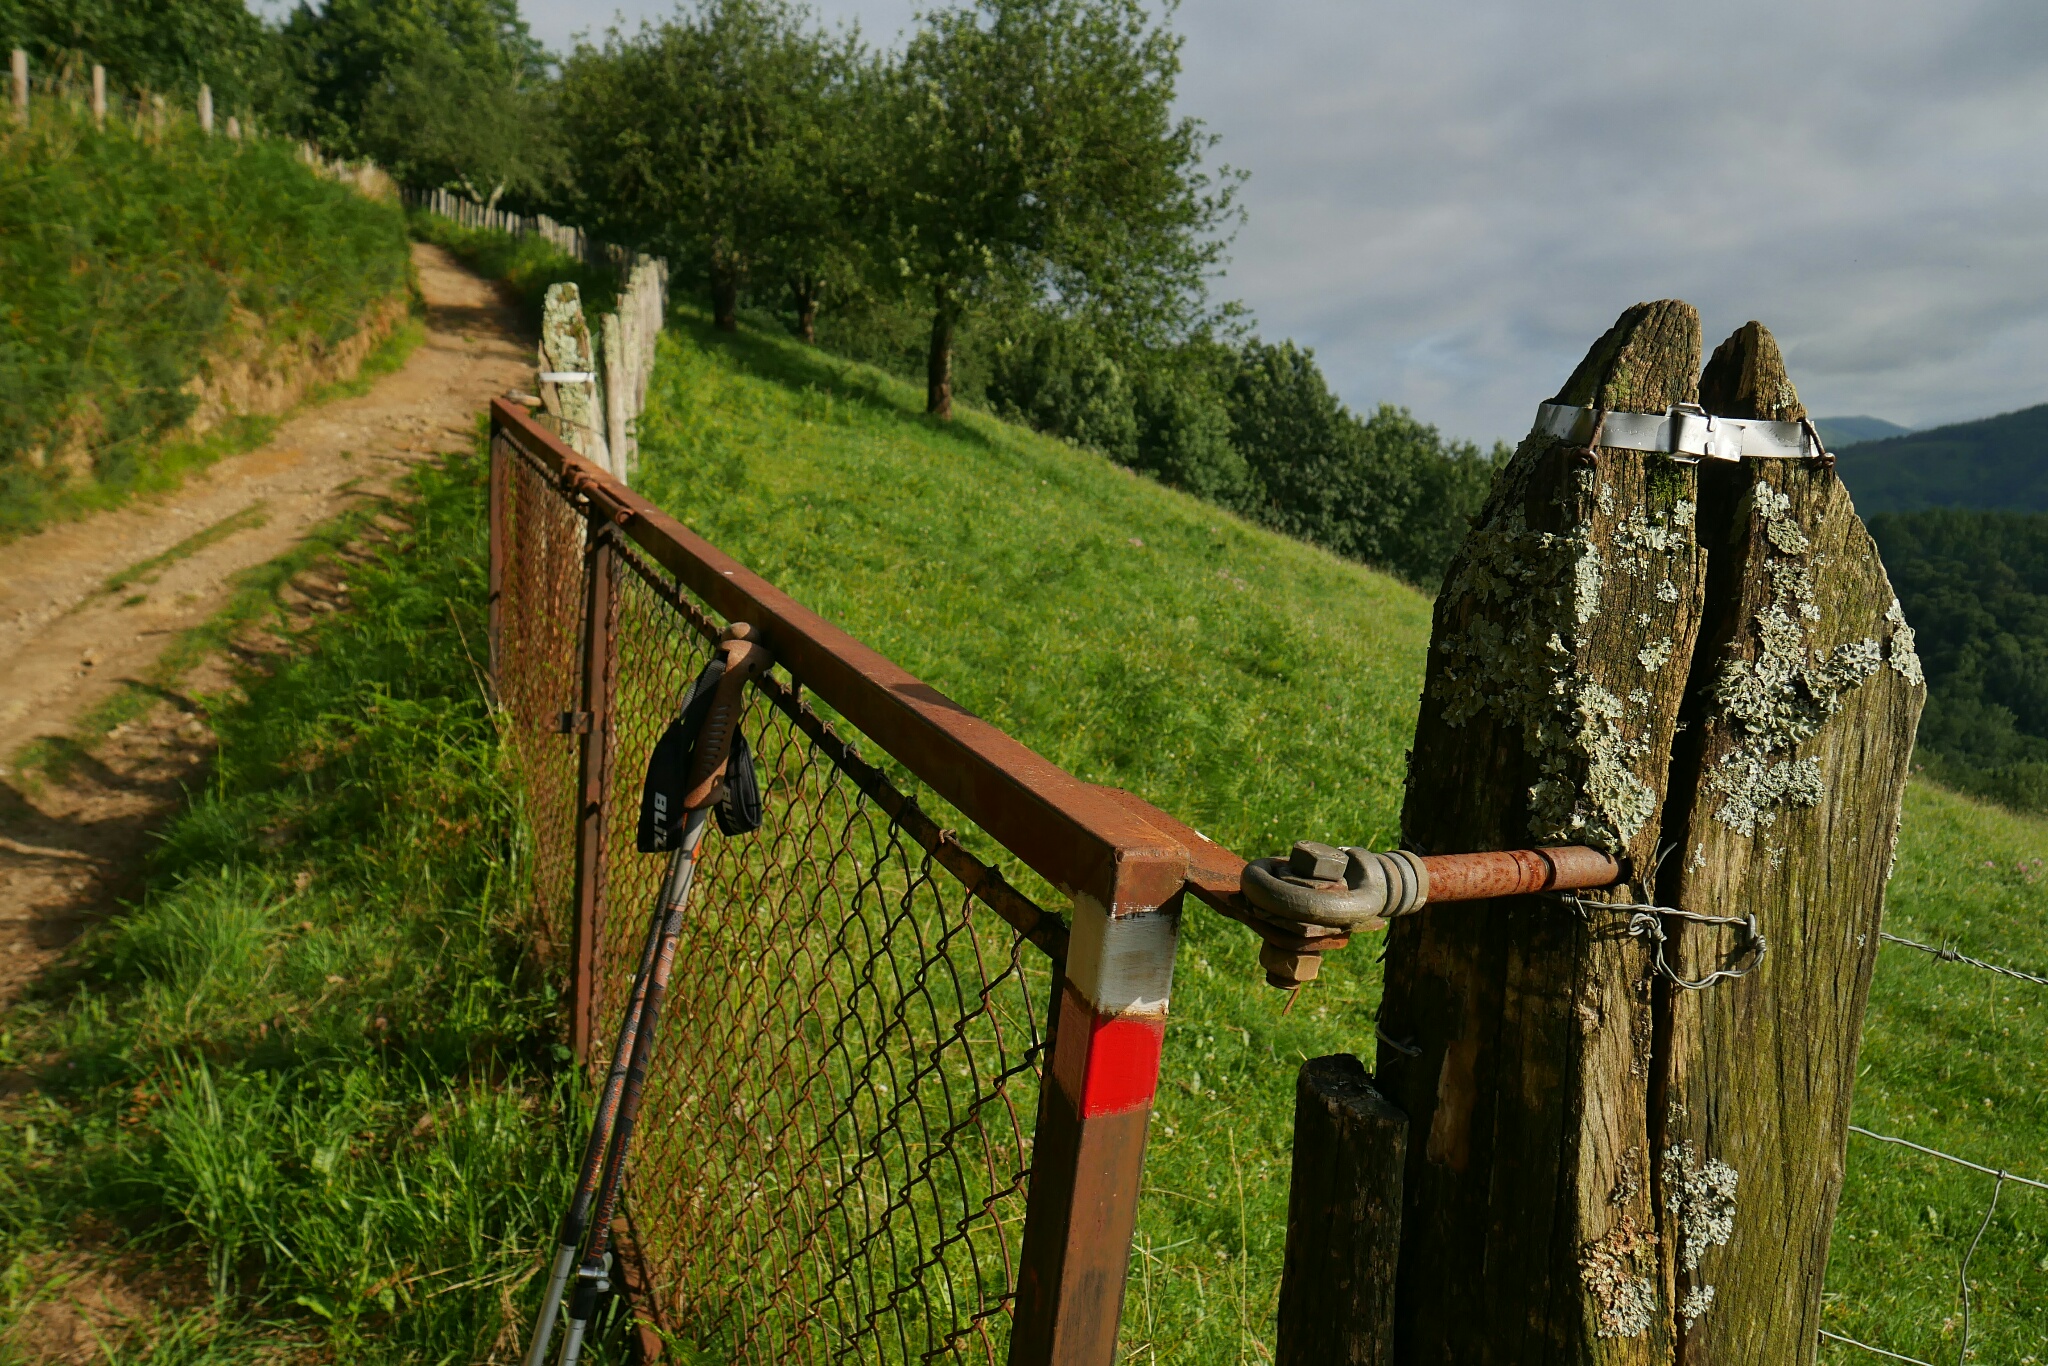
500,444,1063,1364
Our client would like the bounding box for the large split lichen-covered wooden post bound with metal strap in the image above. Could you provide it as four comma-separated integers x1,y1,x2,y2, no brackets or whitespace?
1376,301,1921,1366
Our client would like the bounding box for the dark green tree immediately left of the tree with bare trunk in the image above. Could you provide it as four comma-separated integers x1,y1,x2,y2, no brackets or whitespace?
561,0,872,336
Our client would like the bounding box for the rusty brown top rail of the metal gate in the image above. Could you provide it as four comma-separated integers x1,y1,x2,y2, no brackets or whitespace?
492,399,1188,915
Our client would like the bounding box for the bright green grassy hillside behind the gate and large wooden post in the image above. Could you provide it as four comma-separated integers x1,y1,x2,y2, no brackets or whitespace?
639,319,2048,1362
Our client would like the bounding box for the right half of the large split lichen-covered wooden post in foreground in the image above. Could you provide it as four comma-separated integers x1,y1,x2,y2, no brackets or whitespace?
1653,324,1925,1366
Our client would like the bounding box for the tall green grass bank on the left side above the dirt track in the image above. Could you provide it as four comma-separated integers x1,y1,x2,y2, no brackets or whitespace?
0,100,408,539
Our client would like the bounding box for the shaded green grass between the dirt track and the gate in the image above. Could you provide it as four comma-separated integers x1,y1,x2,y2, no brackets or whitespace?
0,457,626,1362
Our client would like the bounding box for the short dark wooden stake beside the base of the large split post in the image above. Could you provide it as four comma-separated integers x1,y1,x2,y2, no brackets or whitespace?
1274,1053,1407,1366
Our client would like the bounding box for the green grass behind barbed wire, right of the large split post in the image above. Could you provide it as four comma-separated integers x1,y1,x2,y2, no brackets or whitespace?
1827,782,2048,1362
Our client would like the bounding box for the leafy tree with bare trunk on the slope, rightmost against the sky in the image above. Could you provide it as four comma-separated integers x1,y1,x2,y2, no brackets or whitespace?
877,0,1237,418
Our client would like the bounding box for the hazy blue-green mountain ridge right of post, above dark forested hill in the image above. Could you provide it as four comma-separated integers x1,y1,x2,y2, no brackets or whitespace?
1821,403,2048,516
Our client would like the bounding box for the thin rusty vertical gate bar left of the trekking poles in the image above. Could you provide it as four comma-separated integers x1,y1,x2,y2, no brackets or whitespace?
563,518,616,1061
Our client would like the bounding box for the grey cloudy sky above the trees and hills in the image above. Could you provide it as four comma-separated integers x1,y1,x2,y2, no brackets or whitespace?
524,0,2048,440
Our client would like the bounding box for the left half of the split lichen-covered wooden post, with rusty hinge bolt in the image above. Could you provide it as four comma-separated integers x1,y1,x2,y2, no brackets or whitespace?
1376,301,1706,1366
